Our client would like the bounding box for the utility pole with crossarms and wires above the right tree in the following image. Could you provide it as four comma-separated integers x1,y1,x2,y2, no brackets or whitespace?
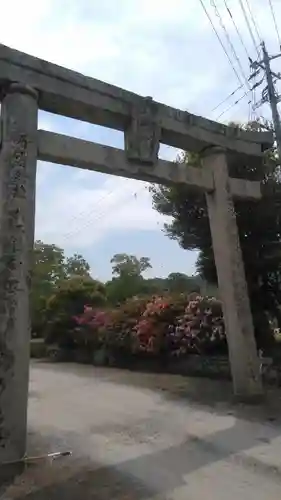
249,42,281,159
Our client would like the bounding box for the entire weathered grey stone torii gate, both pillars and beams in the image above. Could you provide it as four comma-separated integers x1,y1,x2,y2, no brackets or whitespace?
0,45,273,464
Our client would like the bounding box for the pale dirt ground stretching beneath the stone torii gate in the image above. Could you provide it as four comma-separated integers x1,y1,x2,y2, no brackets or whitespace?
0,362,281,500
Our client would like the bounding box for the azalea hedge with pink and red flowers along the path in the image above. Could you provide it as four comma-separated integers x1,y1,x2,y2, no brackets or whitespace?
44,294,227,362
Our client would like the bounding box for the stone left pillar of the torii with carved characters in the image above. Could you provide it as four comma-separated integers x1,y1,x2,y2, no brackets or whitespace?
0,83,38,469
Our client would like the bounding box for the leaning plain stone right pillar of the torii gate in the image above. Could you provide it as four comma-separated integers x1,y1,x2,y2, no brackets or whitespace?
203,147,263,401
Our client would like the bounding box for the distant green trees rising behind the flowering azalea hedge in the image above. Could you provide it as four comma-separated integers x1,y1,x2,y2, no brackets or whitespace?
31,241,205,336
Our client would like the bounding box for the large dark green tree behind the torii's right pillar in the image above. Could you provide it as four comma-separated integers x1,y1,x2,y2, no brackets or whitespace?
151,123,281,346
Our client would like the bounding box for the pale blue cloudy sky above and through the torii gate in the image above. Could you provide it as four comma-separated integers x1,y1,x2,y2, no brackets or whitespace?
0,0,281,279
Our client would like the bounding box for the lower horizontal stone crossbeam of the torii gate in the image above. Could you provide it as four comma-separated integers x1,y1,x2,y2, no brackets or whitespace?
38,130,261,200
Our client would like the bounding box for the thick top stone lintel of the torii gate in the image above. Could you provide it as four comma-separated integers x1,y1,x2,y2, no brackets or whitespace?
0,45,273,156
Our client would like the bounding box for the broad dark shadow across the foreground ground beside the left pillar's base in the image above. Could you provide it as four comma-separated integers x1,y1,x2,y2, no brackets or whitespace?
1,421,281,500
